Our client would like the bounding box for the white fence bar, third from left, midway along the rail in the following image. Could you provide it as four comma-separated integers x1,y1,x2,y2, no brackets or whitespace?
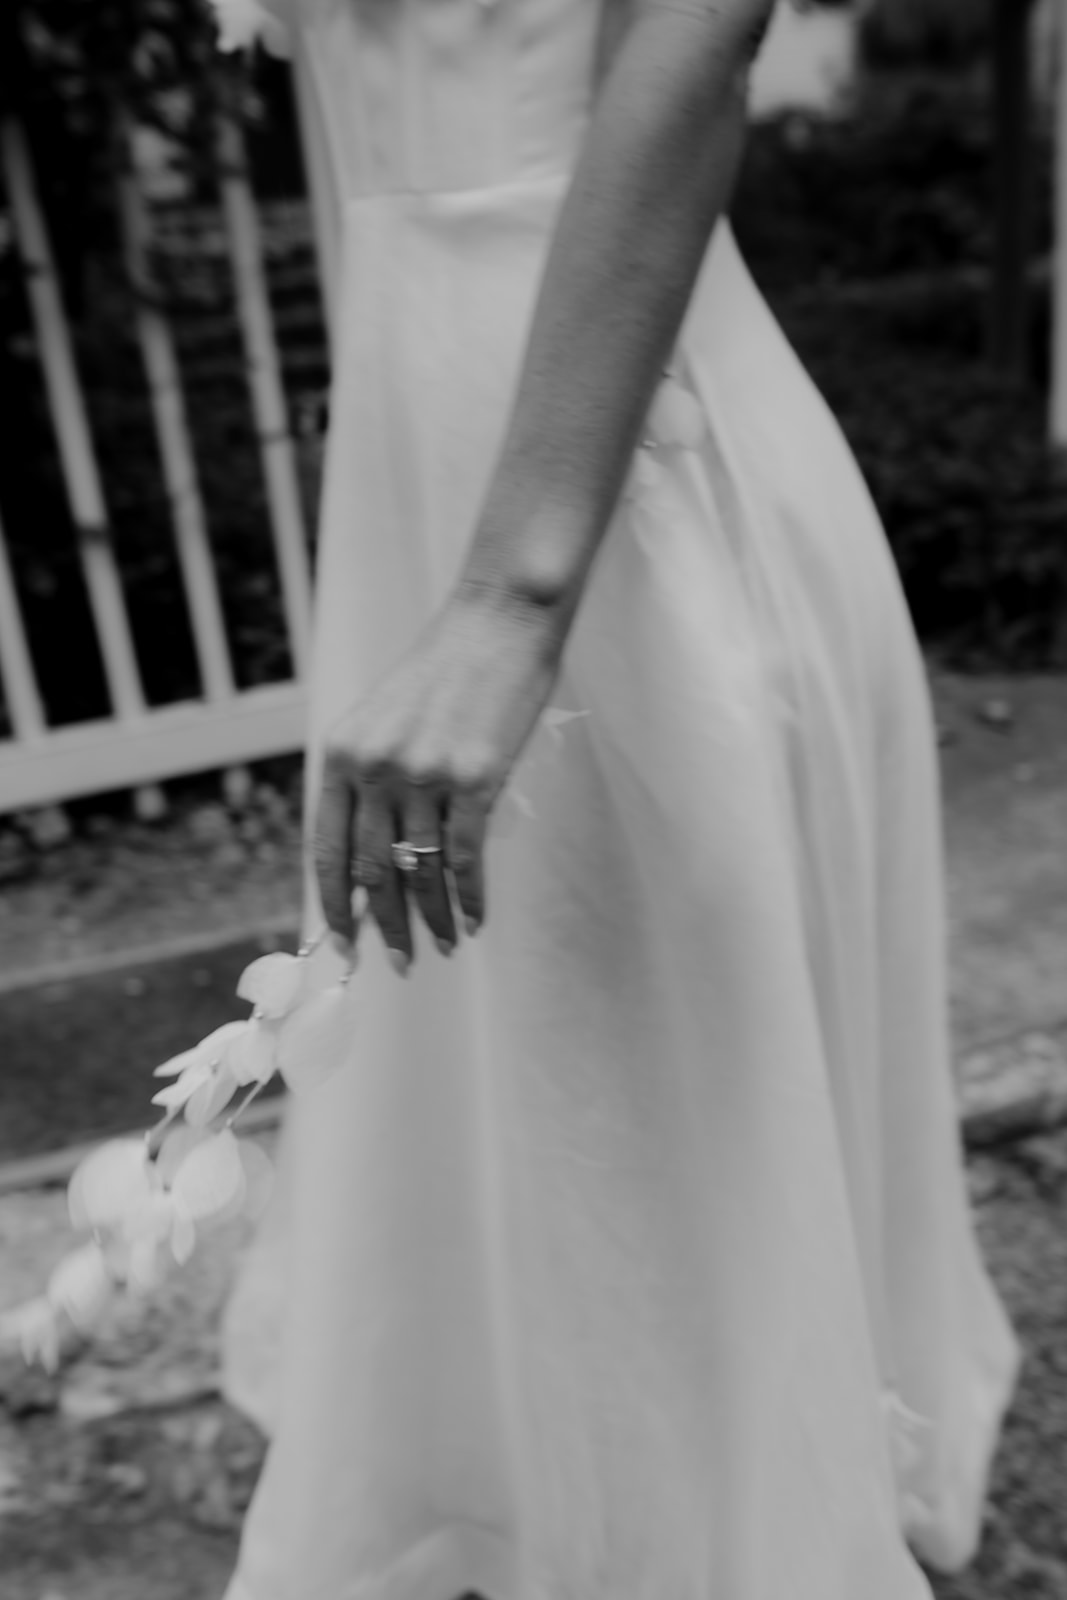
117,118,234,701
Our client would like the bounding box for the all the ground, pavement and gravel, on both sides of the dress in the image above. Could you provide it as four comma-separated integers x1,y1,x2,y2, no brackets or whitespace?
0,675,1067,1600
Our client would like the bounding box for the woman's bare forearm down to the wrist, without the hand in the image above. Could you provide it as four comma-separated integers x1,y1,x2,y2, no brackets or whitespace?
461,0,769,648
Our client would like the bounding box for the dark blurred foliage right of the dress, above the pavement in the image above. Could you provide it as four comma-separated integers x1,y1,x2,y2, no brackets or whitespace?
734,74,1067,666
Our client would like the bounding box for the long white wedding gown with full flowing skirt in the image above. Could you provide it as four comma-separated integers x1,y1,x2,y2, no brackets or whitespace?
217,0,1016,1600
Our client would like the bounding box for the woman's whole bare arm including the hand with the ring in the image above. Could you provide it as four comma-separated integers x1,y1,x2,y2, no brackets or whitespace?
315,0,773,971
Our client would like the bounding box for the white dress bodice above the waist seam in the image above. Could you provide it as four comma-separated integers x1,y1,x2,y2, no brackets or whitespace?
270,0,598,200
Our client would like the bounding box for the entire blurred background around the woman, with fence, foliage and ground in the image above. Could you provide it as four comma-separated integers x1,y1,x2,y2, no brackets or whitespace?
0,0,1067,1600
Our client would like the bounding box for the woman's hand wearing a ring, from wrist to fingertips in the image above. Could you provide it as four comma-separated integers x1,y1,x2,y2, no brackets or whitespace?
314,598,558,973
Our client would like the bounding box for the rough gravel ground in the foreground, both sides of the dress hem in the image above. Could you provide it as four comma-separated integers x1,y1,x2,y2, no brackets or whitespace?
0,1133,1067,1600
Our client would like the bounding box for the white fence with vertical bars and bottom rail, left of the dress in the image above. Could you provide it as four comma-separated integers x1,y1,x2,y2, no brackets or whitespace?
0,78,326,813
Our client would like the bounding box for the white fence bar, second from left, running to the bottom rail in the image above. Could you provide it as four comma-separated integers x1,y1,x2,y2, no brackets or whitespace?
0,117,144,718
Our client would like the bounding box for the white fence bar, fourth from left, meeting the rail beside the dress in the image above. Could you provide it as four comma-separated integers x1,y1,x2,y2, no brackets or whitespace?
218,115,310,677
